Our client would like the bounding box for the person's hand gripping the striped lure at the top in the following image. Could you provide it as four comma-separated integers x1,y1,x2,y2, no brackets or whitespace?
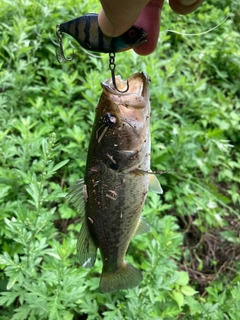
98,0,204,55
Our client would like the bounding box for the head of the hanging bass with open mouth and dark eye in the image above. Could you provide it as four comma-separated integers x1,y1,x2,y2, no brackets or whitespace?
93,72,150,172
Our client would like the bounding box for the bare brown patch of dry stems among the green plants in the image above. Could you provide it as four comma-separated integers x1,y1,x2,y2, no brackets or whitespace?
178,216,240,295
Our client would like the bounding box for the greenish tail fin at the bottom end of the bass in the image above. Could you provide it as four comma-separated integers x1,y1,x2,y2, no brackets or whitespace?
99,263,143,292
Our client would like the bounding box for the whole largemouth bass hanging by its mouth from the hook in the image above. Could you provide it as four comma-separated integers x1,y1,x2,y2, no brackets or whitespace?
69,72,163,293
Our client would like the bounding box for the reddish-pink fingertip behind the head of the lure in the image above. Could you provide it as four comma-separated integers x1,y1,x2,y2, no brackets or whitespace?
134,0,164,55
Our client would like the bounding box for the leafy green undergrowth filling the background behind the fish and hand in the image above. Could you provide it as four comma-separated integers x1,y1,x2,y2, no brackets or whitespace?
0,0,240,320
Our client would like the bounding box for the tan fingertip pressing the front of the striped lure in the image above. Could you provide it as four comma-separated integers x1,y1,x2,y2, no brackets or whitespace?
98,0,149,37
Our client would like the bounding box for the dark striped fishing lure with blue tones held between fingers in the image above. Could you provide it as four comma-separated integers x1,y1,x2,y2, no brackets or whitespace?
57,13,147,53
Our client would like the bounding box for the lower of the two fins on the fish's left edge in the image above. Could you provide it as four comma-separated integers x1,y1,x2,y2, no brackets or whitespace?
77,220,97,268
